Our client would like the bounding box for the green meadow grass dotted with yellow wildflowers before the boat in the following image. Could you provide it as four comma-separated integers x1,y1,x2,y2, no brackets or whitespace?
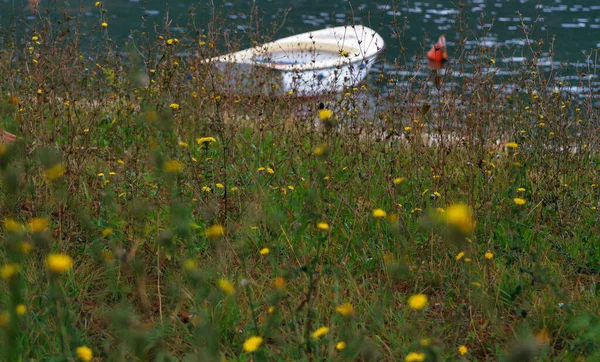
0,4,600,361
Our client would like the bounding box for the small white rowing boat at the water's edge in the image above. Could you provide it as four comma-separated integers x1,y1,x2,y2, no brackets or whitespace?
206,25,384,96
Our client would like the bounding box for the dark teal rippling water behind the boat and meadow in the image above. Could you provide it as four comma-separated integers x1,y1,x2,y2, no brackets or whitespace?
0,0,600,99
